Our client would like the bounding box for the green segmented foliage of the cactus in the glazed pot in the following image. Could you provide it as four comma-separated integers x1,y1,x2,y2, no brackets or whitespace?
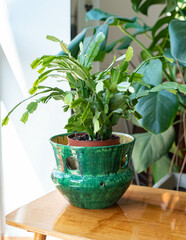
2,32,160,140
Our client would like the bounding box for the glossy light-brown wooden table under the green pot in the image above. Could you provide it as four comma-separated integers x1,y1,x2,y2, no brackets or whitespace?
6,185,186,240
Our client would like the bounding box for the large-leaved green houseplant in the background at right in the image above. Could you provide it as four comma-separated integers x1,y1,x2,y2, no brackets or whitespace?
64,1,186,188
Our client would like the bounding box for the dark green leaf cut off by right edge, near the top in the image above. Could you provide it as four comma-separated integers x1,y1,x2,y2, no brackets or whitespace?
169,19,186,63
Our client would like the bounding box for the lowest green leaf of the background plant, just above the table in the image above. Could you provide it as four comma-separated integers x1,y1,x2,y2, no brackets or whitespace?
152,155,179,183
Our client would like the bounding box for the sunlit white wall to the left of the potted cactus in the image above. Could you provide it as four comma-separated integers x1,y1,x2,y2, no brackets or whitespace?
0,0,70,236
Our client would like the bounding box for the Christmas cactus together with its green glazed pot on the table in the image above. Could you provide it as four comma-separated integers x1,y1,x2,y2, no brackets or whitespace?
2,32,172,209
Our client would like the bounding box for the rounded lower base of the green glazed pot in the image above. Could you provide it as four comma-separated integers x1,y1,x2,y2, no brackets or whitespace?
52,168,133,209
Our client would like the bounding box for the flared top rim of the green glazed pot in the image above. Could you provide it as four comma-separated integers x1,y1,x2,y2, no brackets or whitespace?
49,132,136,149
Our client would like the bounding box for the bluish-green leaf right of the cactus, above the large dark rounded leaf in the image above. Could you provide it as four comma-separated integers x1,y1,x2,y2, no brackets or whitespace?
138,59,162,86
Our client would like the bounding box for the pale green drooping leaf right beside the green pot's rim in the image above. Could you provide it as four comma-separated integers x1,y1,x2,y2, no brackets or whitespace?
132,127,174,173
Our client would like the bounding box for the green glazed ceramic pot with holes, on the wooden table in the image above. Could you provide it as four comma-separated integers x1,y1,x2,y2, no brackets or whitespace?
50,133,135,209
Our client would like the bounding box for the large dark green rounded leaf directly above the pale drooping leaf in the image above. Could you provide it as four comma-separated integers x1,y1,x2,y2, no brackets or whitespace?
135,90,178,134
